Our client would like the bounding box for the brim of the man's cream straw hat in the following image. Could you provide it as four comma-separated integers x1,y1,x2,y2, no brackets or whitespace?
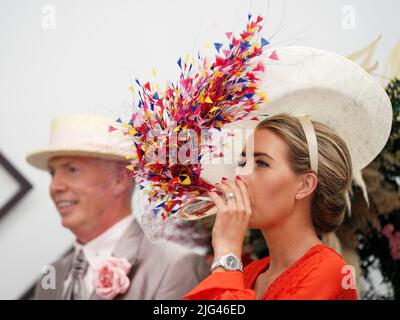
26,148,129,171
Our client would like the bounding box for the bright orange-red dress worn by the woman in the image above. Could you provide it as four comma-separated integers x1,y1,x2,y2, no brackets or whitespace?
183,244,357,300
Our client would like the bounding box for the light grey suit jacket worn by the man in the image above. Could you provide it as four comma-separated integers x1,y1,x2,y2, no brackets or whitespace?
33,221,209,300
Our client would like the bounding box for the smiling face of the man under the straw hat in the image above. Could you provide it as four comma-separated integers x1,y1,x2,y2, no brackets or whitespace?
49,156,115,233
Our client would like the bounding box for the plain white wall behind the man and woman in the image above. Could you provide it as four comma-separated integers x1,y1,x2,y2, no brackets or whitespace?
0,0,400,299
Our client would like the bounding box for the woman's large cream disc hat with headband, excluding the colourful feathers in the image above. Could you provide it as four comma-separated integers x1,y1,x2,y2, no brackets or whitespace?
185,47,393,219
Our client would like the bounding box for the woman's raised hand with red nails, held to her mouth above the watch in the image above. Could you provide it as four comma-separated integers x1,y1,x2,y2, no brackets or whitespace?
209,176,252,259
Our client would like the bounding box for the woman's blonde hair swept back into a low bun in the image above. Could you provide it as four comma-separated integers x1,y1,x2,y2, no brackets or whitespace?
257,114,352,235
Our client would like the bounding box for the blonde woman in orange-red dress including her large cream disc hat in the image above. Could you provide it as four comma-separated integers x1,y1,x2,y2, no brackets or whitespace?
184,47,392,300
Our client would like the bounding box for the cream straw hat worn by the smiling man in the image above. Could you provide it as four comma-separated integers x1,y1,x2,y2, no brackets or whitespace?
27,114,133,170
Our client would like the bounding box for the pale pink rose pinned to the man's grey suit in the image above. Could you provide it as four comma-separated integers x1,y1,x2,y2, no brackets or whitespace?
93,257,132,300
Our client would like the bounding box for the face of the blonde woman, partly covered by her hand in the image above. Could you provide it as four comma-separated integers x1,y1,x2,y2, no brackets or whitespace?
239,129,301,228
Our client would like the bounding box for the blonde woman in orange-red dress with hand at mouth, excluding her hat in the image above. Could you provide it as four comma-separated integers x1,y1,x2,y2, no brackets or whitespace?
184,114,357,300
